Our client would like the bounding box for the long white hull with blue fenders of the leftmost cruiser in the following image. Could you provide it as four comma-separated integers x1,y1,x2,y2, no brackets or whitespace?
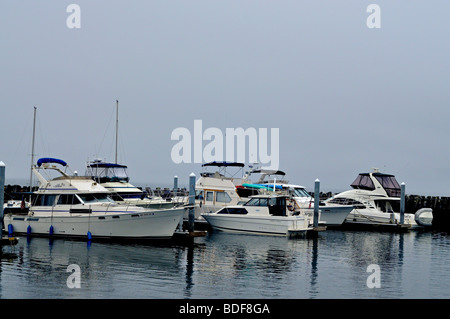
4,208,184,239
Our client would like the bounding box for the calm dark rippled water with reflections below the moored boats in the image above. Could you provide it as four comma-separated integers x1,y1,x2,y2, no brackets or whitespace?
0,230,450,299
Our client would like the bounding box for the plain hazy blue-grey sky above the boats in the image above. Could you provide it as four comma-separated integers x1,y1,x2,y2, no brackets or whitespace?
0,0,450,196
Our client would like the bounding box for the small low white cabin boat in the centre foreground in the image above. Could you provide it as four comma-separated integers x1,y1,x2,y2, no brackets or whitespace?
202,194,314,237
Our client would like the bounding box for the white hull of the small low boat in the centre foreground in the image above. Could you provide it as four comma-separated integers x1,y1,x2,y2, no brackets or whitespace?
202,214,312,236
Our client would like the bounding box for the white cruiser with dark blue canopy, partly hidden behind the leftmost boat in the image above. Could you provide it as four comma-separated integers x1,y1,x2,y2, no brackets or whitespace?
85,159,174,208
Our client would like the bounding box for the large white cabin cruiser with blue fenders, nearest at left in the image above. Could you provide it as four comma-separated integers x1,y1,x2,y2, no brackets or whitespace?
4,158,184,239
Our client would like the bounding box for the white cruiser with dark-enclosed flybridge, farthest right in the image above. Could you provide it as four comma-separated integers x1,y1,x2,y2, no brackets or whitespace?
325,169,432,229
